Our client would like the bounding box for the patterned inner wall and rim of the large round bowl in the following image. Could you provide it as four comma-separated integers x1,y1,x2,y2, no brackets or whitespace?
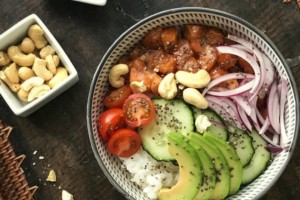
87,8,299,200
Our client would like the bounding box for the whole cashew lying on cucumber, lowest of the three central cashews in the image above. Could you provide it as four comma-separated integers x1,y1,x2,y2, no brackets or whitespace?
182,88,208,109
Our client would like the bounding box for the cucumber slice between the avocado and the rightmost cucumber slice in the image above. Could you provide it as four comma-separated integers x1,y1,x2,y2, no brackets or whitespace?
228,126,255,167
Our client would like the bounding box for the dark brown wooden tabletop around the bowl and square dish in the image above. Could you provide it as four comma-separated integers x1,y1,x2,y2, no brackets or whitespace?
0,0,300,200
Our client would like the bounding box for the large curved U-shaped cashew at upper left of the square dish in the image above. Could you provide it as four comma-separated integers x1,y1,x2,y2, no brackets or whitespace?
7,46,35,67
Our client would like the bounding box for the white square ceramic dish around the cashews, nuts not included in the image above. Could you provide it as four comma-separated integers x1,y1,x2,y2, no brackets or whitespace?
0,14,79,117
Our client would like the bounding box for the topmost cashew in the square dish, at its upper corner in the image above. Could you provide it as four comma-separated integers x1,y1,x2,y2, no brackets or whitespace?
28,24,48,49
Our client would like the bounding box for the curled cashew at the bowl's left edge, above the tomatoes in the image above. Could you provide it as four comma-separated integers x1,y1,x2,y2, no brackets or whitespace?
108,64,129,88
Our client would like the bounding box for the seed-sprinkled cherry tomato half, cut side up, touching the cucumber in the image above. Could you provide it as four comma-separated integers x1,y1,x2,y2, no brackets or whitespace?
123,93,155,127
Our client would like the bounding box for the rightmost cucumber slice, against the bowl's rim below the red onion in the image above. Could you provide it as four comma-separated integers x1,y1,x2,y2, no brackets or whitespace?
242,130,271,184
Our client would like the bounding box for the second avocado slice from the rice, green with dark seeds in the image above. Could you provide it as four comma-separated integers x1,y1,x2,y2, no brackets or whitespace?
194,142,217,200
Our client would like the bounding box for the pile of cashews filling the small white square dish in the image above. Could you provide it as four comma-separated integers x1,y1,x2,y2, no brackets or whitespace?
0,24,68,102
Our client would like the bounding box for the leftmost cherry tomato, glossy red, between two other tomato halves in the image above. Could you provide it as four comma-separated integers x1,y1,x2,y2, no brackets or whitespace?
98,108,126,141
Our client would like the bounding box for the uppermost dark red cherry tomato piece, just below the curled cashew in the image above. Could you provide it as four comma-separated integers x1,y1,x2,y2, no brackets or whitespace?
103,85,132,108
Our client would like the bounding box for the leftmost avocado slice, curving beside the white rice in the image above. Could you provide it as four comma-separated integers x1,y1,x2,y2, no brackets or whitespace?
158,132,202,200
